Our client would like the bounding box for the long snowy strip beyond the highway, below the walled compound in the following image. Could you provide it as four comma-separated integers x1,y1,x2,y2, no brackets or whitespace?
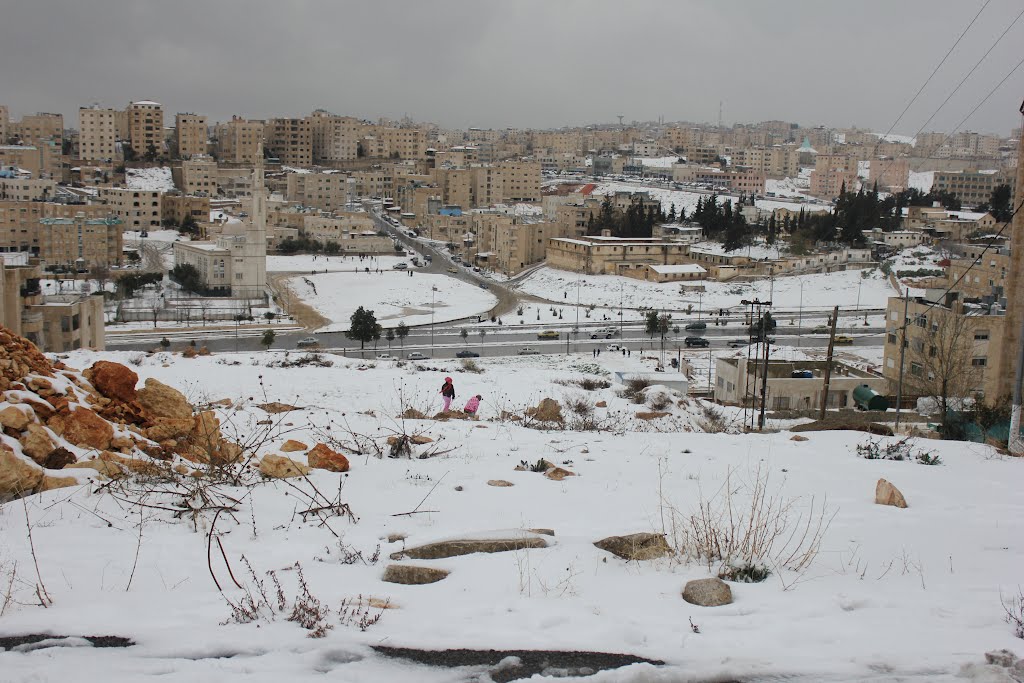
518,266,898,311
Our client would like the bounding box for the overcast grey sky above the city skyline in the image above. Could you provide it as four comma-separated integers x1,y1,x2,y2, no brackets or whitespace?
0,0,1024,134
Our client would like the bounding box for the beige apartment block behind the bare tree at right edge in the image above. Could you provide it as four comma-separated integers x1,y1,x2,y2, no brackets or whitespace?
883,290,1007,399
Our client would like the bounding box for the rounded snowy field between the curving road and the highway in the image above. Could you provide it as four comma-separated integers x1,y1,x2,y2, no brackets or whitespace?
288,264,498,332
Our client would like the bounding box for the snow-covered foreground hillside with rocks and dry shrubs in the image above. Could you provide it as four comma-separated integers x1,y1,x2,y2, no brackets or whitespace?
0,348,1024,683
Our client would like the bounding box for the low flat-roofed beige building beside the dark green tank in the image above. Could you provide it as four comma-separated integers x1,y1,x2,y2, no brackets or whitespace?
715,354,888,411
